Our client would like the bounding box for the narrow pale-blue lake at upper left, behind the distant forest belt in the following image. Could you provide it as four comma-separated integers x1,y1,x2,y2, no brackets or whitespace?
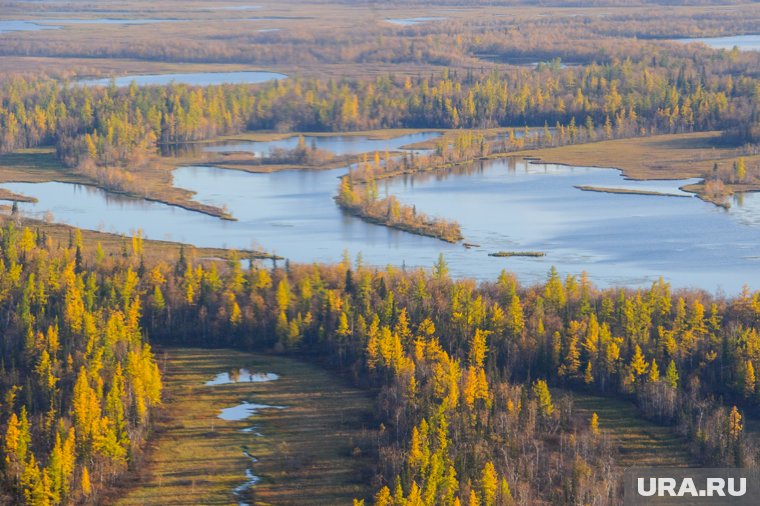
75,71,288,87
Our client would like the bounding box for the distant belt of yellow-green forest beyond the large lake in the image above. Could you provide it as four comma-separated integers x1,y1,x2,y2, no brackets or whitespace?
0,55,760,206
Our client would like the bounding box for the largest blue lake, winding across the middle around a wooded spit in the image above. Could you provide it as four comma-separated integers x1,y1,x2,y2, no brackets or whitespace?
2,134,760,294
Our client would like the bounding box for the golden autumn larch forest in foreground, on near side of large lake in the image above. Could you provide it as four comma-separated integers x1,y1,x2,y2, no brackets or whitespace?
0,222,760,505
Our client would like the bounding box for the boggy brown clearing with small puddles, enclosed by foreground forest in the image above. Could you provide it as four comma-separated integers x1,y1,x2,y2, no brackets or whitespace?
111,349,374,505
